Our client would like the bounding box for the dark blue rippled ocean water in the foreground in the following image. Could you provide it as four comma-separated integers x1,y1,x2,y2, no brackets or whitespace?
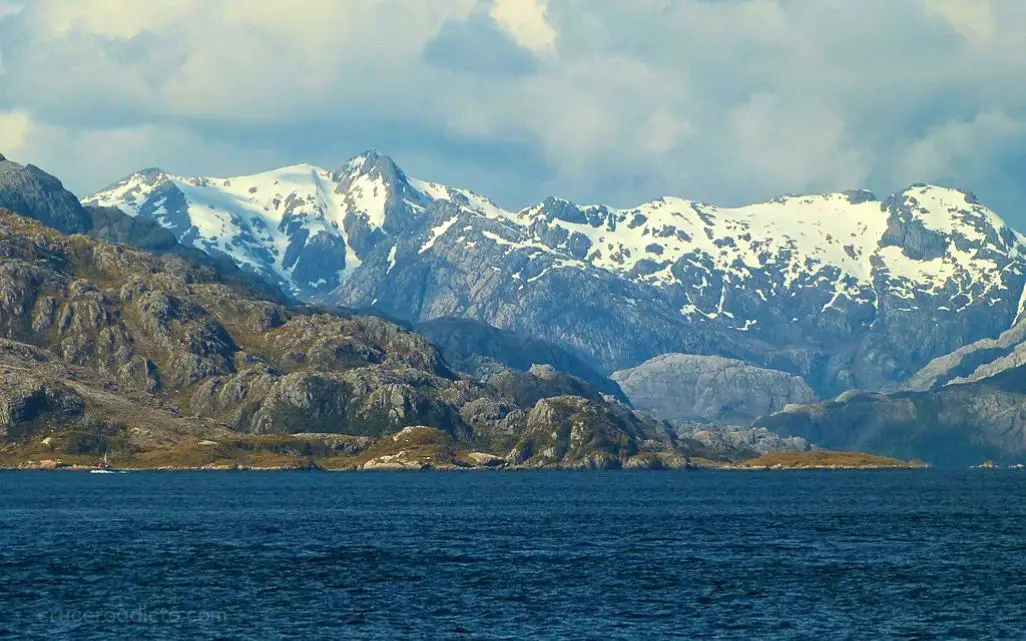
0,471,1026,640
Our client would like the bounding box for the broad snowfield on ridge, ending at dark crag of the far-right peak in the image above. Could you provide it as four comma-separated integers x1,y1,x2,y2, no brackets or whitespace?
510,194,886,284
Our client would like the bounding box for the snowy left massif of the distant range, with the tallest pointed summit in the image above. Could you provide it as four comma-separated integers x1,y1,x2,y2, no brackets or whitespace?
83,152,465,296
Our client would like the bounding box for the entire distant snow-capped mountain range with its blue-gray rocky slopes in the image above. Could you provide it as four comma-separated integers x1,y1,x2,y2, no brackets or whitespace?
85,153,1026,394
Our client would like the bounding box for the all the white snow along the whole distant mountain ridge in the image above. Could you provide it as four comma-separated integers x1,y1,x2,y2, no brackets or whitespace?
85,152,1026,311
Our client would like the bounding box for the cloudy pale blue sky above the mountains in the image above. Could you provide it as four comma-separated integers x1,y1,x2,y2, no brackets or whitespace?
0,0,1026,224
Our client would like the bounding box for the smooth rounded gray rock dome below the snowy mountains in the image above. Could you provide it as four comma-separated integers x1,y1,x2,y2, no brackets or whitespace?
613,354,816,426
